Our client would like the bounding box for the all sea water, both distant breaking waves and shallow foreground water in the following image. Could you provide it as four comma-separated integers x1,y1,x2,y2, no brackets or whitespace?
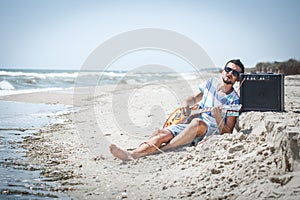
0,69,214,199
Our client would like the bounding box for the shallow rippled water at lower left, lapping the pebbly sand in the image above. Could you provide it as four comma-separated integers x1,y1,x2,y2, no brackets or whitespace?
0,101,69,199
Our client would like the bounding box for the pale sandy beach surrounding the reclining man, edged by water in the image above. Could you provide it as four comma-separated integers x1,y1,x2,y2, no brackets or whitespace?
0,75,300,199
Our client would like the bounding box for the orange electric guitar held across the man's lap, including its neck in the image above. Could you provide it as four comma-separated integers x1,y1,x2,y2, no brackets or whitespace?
163,104,242,128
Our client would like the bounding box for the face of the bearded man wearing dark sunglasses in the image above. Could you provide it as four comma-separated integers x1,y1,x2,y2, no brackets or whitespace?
222,63,242,85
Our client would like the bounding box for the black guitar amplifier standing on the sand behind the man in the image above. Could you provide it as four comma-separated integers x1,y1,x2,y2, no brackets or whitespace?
240,74,284,111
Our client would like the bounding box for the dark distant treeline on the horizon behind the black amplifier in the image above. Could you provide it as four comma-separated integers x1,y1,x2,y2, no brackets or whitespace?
246,59,300,75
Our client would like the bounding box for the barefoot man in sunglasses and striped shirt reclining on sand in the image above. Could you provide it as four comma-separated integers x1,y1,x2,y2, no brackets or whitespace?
110,59,244,161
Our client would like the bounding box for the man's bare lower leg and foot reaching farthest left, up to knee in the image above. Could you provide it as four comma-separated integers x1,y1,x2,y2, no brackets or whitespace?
109,129,173,161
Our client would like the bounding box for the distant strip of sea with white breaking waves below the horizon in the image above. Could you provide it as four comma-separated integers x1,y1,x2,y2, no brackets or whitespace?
0,69,209,96
